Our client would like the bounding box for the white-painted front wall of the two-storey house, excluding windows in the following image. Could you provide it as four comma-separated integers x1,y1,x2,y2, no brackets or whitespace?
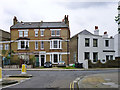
78,34,115,63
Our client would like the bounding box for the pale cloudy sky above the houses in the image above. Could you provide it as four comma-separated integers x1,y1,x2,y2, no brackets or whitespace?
0,0,118,37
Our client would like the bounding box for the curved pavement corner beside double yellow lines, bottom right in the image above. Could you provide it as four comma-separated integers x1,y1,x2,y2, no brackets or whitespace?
78,72,120,90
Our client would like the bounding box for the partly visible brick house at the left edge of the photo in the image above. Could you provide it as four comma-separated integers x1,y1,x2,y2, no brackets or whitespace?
0,29,10,66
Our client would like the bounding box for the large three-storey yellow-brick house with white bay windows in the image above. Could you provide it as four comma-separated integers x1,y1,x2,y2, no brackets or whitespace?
10,15,70,66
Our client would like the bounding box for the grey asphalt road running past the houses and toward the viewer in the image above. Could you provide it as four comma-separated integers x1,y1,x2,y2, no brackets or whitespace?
3,69,118,88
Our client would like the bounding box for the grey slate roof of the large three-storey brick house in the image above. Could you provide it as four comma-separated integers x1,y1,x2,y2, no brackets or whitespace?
10,22,68,29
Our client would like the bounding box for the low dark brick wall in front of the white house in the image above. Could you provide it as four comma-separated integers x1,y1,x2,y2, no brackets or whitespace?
88,59,120,68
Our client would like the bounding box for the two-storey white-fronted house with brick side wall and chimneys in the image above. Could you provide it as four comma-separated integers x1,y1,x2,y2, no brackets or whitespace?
70,26,115,67
